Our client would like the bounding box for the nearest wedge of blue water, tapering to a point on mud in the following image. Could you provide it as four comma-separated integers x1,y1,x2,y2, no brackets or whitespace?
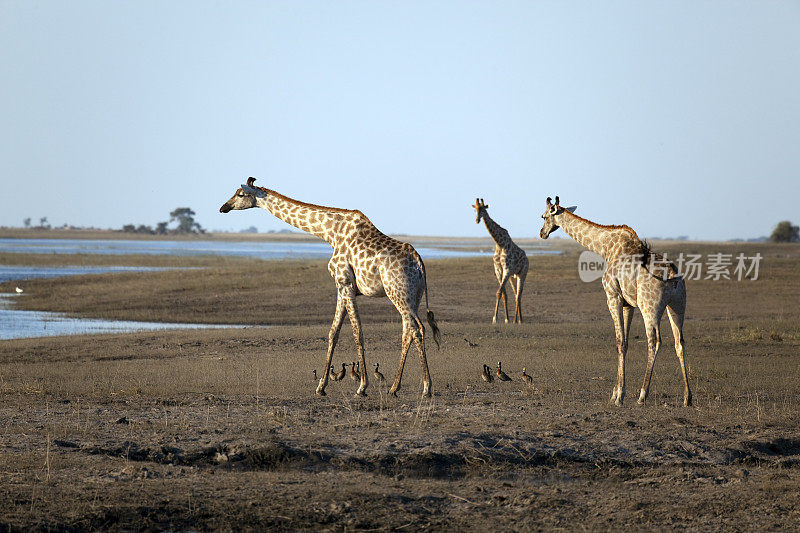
0,293,246,340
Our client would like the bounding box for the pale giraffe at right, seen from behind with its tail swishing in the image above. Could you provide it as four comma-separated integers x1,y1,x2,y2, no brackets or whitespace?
539,196,692,407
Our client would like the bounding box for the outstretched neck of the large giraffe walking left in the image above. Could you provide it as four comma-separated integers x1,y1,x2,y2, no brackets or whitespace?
258,189,359,246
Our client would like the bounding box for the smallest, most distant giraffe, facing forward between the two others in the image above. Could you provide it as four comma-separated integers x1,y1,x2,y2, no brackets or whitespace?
472,198,528,324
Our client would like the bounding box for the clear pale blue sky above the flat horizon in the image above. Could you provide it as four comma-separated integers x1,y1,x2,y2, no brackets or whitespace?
0,0,800,239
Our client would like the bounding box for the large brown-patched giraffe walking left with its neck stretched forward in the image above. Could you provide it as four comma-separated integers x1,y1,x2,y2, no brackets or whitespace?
219,177,439,398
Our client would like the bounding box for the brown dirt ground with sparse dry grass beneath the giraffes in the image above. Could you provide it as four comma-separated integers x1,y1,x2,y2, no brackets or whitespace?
0,243,800,531
